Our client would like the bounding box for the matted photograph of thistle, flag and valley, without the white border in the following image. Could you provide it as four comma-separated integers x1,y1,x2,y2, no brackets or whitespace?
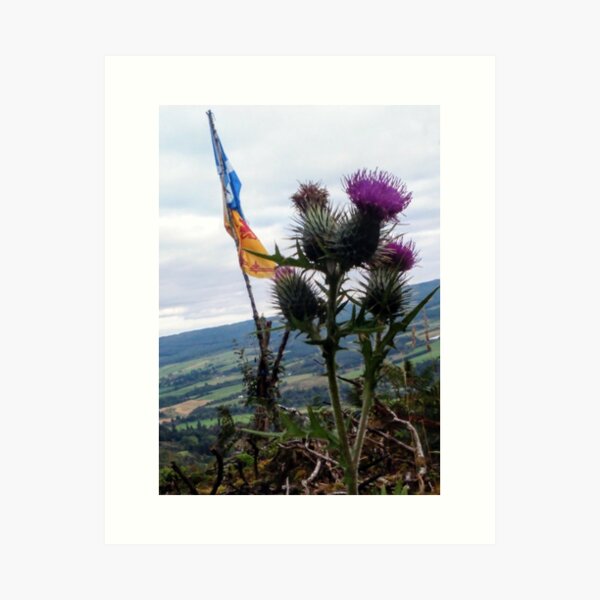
158,106,441,495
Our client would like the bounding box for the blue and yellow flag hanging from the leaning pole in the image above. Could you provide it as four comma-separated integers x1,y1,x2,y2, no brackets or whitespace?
207,111,276,277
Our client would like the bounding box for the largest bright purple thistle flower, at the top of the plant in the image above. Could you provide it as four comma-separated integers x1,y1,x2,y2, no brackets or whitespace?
342,169,412,221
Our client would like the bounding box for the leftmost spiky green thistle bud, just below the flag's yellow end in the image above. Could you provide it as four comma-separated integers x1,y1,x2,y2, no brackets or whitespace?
273,267,321,326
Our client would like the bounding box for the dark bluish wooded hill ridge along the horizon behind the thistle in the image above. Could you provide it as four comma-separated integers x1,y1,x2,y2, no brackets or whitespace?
159,279,440,367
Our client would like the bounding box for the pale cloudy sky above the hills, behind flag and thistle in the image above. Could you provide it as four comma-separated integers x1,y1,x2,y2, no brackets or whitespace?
160,106,440,335
